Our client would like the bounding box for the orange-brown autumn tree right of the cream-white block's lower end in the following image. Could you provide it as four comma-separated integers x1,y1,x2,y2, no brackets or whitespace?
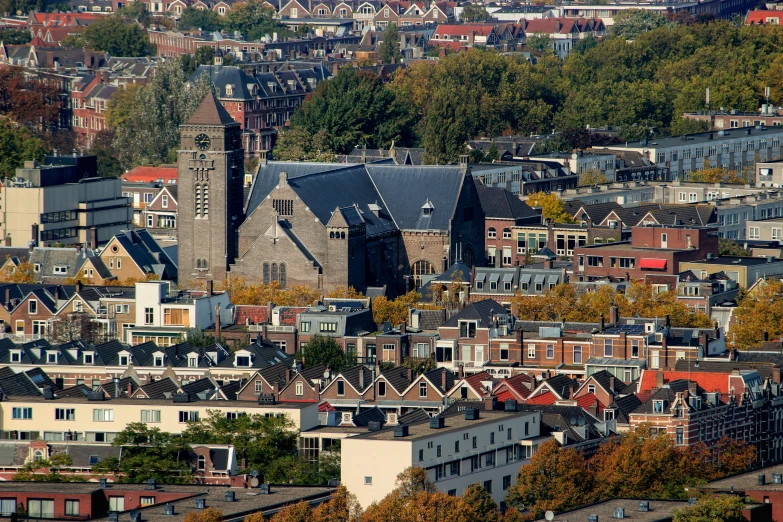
506,440,595,518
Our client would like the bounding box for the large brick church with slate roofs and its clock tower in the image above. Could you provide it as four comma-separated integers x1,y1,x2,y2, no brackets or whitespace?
178,95,484,295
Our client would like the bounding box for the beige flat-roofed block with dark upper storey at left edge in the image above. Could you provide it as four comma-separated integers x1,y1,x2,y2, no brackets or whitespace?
0,156,133,247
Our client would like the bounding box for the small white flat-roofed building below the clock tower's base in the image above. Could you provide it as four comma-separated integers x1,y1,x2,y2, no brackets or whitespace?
125,281,231,346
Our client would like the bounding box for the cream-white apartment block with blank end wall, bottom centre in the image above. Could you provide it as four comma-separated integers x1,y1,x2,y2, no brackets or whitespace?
341,409,544,508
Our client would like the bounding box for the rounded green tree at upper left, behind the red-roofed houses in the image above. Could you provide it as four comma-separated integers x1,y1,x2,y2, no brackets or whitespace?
63,15,153,57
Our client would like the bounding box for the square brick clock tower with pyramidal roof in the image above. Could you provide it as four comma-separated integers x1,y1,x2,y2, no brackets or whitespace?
177,92,245,287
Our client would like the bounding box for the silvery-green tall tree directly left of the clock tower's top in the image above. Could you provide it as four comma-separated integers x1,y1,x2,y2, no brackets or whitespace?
108,58,212,168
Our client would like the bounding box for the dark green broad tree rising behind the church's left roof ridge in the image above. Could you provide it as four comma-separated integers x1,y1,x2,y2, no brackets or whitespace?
288,66,412,154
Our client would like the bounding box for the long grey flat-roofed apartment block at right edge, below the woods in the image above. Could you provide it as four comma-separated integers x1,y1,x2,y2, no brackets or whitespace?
606,126,783,180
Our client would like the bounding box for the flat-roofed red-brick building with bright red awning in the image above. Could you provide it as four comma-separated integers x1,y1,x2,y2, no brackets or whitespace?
574,222,718,281
